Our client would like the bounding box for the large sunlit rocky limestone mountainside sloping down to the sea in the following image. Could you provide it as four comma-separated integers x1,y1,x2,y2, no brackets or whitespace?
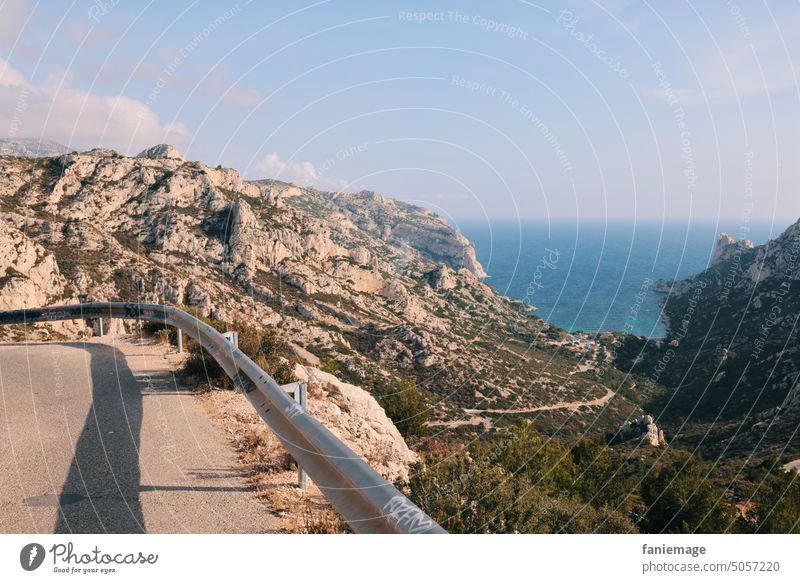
0,145,642,434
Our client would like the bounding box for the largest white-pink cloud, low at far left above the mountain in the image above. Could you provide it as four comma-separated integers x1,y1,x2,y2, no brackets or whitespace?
0,59,188,153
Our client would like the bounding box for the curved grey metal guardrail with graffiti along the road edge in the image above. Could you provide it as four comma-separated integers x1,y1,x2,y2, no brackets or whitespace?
0,302,446,534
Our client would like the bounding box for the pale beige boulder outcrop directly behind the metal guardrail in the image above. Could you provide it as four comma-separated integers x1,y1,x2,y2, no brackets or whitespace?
294,365,417,481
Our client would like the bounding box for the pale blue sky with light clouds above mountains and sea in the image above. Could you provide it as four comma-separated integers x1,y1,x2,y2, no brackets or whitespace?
0,0,800,224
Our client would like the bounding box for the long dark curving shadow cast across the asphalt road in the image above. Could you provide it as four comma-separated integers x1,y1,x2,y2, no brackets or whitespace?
54,344,145,533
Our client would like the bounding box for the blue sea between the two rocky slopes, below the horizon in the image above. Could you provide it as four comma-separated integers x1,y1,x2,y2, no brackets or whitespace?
458,219,791,338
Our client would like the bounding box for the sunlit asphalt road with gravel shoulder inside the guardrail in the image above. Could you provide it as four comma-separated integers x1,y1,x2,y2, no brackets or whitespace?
0,338,277,533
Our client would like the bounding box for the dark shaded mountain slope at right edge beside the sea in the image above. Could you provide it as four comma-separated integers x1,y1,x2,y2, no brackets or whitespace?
620,221,800,455
